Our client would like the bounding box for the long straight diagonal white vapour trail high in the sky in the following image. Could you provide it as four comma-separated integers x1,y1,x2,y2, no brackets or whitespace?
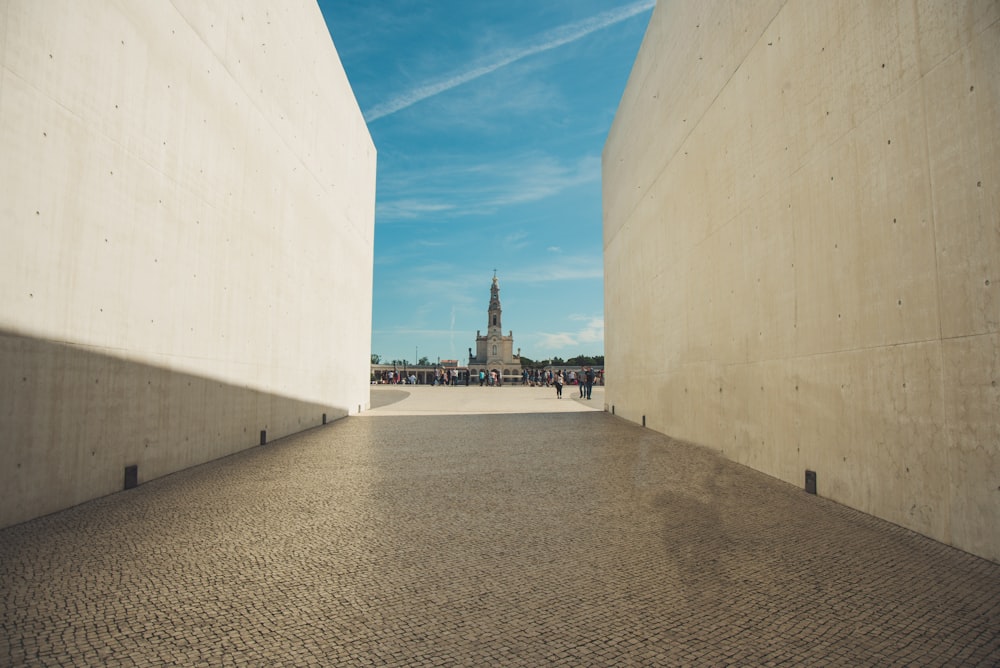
365,0,656,123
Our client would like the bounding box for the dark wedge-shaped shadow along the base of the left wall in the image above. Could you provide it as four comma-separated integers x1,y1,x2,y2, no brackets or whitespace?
0,331,349,528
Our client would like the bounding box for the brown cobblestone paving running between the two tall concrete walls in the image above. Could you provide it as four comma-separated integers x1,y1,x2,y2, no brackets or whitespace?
0,388,1000,666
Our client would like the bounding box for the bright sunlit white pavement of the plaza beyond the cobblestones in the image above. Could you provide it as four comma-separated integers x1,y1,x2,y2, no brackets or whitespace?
361,385,604,417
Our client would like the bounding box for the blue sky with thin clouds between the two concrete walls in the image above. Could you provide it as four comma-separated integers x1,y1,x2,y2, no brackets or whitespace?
319,0,655,362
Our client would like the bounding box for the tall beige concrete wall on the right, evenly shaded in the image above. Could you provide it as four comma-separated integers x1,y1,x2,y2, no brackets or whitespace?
604,0,1000,560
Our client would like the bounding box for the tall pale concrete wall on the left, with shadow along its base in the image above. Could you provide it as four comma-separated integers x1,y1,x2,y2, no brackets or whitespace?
0,0,375,526
